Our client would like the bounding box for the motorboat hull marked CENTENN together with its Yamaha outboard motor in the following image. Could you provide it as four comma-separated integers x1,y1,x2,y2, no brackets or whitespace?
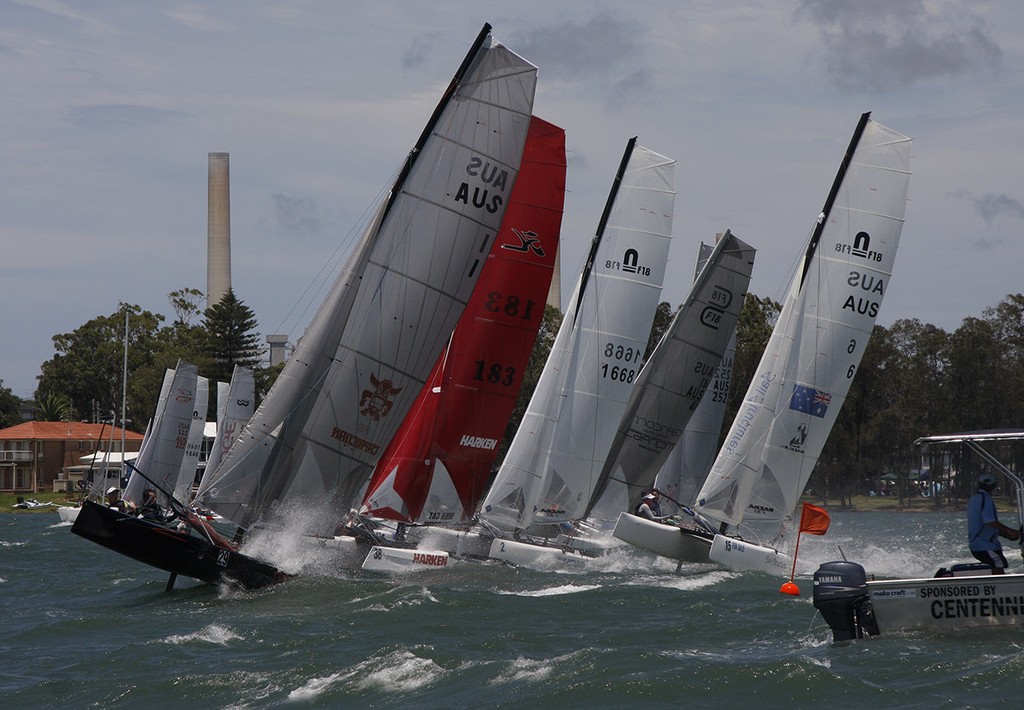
814,560,1024,641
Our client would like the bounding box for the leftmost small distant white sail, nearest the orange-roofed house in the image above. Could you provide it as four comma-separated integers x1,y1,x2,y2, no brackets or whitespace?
125,360,199,505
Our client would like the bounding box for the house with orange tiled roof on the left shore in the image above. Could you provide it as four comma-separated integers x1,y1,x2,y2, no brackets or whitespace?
0,421,142,493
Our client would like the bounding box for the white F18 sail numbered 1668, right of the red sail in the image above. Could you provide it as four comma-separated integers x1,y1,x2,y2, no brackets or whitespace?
480,138,676,528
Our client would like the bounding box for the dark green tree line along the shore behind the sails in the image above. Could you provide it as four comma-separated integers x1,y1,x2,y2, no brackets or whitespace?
0,289,1024,505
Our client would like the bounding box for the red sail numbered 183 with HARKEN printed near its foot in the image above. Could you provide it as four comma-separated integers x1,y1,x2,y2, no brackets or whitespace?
362,117,565,523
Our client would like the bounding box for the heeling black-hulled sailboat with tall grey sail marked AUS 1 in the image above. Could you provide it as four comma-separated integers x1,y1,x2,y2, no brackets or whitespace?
71,25,537,588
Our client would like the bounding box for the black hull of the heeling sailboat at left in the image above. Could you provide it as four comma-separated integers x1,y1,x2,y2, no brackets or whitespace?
71,501,290,589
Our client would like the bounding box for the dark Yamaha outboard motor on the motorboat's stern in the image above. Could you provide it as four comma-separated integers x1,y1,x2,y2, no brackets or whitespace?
814,561,879,641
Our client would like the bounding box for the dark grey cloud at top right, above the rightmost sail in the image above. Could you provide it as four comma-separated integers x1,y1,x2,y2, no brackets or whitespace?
796,0,1002,90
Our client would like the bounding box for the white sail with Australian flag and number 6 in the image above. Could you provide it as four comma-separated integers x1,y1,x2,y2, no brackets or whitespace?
697,114,910,526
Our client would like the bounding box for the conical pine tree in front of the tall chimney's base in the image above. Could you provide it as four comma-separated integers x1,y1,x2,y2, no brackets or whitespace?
205,289,261,382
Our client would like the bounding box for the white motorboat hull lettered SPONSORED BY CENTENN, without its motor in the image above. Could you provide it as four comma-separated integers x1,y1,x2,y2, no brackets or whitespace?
867,574,1024,634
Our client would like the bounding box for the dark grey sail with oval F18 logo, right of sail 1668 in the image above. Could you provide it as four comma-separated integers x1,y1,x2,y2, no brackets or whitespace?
592,232,755,520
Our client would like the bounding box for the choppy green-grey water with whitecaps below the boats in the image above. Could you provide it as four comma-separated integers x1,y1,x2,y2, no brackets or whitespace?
0,512,1024,708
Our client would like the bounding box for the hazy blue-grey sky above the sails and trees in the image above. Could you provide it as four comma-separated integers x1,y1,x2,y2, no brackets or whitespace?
0,0,1024,398
